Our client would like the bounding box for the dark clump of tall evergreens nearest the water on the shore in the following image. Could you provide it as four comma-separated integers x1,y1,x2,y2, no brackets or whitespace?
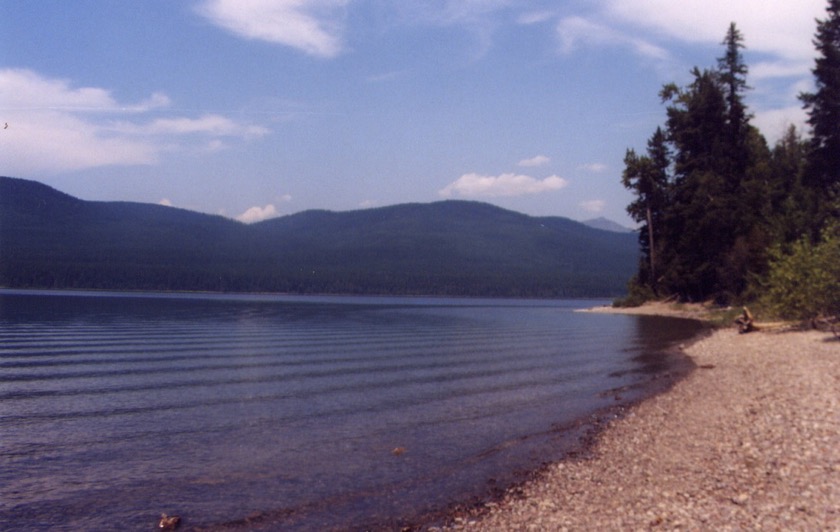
623,23,772,301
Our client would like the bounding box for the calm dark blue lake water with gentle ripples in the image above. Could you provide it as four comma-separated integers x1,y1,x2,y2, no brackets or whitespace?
0,290,700,530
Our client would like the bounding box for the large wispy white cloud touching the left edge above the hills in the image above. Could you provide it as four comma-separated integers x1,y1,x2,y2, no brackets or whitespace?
0,69,268,176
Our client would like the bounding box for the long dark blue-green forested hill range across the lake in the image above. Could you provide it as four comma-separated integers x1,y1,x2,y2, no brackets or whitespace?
0,177,638,297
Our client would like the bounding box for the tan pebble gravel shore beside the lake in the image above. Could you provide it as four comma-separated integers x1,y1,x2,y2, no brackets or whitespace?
447,309,840,531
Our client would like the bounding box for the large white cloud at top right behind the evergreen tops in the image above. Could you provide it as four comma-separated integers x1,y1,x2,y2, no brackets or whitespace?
557,0,826,142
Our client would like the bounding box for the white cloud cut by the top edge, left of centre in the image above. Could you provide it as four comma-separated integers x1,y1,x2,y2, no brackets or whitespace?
198,0,348,57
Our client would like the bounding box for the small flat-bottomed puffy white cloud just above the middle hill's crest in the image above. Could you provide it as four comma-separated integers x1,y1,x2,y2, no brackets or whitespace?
438,174,568,198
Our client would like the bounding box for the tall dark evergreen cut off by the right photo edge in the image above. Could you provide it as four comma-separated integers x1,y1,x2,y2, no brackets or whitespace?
800,0,840,230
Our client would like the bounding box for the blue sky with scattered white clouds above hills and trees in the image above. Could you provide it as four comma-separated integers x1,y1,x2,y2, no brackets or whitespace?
0,0,827,226
